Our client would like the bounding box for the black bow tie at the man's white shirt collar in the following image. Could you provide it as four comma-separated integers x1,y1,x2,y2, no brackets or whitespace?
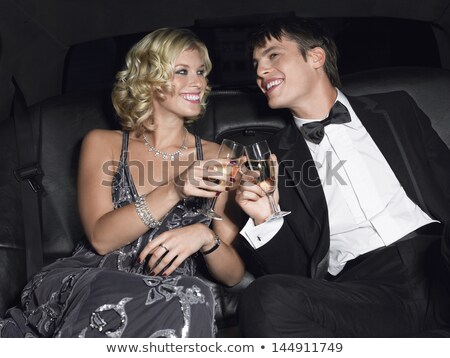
301,101,351,144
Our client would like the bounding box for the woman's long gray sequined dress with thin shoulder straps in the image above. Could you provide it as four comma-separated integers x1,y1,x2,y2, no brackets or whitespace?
0,132,215,338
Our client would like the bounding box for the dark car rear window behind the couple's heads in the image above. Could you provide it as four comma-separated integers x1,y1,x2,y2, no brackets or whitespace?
63,18,441,92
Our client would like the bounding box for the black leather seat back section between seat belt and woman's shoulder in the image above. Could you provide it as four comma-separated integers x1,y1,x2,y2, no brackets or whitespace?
36,92,118,263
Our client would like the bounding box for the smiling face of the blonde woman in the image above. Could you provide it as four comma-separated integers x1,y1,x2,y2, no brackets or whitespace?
154,50,206,118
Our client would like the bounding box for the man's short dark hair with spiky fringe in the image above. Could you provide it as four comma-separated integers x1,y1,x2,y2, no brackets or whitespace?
249,16,341,87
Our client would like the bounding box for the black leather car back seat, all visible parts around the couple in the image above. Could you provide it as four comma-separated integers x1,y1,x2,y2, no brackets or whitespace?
0,68,450,336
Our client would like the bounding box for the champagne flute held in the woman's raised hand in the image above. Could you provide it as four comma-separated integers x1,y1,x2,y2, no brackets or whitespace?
199,139,245,220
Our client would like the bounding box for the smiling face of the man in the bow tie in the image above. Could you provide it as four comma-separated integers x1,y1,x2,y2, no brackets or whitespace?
253,37,317,110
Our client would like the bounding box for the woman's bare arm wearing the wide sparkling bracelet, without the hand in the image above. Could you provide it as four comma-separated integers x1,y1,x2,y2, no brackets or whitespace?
78,130,180,255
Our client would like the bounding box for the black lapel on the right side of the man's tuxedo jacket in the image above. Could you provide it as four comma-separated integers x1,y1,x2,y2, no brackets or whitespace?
348,97,418,206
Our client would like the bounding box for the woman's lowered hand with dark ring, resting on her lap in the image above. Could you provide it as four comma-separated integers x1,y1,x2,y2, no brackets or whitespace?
138,223,214,276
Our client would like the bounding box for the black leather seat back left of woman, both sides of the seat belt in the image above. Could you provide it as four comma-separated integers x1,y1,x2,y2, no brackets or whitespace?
0,92,116,315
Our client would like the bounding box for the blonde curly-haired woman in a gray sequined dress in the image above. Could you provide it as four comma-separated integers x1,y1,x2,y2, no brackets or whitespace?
0,28,244,337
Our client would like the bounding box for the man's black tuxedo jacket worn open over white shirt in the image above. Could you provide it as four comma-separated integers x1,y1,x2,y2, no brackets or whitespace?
246,91,450,278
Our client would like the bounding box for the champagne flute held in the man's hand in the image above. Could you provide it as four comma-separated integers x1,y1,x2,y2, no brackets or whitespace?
245,140,291,221
